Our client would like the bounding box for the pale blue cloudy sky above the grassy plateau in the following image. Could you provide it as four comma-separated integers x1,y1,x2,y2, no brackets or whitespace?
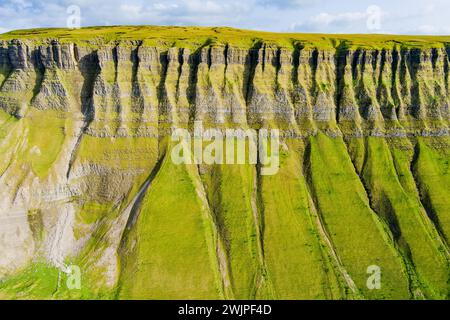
0,0,450,35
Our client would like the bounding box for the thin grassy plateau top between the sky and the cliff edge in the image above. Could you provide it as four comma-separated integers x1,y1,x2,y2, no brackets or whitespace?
0,26,450,49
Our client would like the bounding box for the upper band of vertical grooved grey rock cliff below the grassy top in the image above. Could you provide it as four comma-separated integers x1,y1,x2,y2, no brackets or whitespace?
0,40,449,136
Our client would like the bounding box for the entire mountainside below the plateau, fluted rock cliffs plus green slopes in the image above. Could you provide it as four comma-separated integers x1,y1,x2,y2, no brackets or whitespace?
0,28,450,298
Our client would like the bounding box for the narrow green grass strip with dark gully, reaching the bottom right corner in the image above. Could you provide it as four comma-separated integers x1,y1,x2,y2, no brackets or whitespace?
363,137,449,298
